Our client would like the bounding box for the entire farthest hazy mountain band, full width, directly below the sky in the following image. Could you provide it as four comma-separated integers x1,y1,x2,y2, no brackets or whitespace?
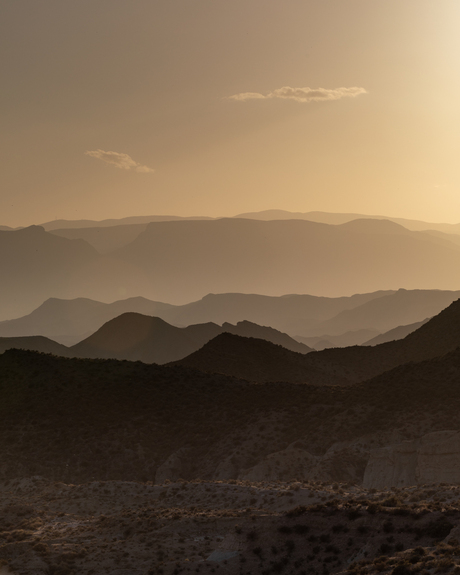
0,216,460,320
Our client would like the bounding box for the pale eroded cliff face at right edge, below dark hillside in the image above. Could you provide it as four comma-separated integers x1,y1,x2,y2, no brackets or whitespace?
363,431,460,489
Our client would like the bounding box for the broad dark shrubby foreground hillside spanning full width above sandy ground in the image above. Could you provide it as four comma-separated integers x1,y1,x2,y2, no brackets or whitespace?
0,350,460,483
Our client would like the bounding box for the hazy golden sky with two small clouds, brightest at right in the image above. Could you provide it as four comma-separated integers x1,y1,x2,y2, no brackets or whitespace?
0,0,460,226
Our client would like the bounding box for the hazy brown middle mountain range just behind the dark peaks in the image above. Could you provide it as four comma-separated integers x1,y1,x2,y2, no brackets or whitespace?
0,290,460,349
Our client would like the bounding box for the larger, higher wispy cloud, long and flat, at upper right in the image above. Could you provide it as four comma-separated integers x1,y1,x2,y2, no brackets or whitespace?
229,86,367,103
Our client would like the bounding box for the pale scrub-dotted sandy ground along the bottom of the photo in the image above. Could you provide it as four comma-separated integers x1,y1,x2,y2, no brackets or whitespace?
0,477,460,575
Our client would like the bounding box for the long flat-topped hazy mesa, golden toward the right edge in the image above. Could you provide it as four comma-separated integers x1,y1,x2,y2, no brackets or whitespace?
93,219,460,301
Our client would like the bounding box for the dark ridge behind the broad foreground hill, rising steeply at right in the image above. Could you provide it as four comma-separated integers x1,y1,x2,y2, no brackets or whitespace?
179,300,460,385
